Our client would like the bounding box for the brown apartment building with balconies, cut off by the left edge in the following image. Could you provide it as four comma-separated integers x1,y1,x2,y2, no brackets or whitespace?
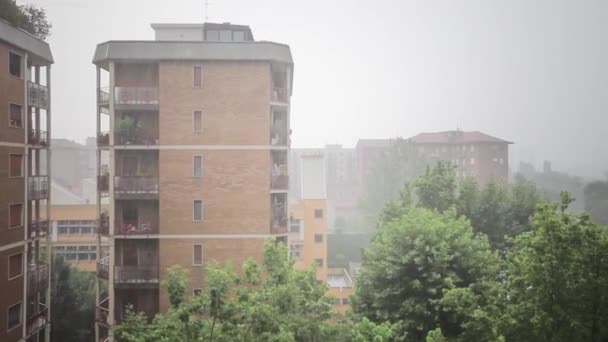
0,20,53,342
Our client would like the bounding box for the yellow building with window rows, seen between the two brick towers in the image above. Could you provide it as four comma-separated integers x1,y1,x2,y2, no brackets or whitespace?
51,204,105,272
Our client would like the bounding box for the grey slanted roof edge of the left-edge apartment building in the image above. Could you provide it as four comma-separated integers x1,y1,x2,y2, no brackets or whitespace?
0,19,53,65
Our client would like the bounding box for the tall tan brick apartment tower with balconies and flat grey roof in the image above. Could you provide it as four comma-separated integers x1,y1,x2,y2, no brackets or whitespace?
93,23,293,340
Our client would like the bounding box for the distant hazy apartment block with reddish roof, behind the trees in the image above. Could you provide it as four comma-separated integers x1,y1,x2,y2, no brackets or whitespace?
410,130,512,183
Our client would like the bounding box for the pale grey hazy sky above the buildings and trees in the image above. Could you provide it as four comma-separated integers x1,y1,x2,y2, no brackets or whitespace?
18,0,608,176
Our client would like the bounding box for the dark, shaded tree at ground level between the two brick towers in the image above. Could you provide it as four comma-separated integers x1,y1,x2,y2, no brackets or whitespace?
51,255,95,342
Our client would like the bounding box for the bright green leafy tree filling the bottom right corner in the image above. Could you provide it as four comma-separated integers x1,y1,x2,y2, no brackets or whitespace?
500,193,608,342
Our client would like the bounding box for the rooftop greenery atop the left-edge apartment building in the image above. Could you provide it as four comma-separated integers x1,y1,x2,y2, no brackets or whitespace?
0,0,52,40
